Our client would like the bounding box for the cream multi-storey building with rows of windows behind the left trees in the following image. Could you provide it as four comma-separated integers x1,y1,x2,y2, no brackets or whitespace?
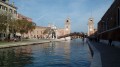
0,0,17,40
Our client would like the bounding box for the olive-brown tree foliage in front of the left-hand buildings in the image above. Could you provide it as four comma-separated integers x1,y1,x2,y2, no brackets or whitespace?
0,14,36,34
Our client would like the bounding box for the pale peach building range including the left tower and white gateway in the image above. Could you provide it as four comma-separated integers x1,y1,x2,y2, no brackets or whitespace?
24,18,71,39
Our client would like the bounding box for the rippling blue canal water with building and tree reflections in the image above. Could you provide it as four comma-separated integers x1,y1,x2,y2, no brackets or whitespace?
0,39,91,67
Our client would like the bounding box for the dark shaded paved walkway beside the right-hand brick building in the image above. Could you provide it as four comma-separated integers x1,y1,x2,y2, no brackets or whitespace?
91,42,120,67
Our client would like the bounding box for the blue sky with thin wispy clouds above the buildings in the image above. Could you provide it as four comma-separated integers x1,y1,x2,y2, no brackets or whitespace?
10,0,114,32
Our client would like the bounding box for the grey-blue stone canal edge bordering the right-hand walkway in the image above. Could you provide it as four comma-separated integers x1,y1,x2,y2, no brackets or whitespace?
88,41,102,67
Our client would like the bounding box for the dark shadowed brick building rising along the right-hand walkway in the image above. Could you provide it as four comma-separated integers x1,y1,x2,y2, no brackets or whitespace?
98,0,120,41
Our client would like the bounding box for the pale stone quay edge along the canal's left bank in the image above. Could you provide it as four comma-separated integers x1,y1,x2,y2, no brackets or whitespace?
0,39,61,48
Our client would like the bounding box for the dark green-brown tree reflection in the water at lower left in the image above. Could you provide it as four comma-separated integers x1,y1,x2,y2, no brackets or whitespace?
0,46,33,67
